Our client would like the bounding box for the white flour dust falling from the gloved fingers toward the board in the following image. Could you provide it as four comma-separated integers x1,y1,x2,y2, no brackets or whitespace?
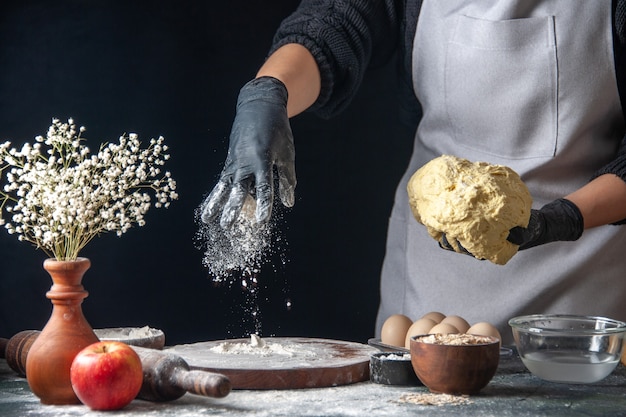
195,196,292,337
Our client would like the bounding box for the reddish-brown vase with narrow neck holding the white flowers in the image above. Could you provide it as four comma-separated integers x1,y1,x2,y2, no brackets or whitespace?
26,258,98,405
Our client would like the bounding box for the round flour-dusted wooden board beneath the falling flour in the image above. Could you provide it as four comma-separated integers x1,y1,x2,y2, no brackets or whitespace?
166,337,378,389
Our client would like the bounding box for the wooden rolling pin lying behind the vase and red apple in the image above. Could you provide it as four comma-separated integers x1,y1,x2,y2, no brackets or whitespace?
4,330,231,401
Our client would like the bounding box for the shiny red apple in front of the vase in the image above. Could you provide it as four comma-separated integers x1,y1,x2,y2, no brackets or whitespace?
70,341,143,410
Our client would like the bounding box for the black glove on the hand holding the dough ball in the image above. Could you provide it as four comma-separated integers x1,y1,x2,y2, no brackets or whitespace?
507,198,584,250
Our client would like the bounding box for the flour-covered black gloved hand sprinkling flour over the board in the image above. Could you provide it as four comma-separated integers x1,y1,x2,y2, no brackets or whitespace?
201,77,296,228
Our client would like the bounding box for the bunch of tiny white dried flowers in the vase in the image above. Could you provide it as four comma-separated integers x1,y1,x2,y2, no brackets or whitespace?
0,118,178,260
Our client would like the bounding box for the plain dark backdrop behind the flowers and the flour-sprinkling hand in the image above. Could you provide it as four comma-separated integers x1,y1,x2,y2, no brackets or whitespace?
0,0,412,344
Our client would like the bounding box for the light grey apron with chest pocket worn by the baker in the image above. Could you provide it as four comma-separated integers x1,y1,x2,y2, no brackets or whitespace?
376,0,626,343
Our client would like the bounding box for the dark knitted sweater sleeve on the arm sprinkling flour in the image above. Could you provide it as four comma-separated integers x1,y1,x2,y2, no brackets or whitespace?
270,0,402,118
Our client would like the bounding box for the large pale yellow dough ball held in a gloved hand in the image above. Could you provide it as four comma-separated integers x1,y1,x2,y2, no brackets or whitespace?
407,155,532,265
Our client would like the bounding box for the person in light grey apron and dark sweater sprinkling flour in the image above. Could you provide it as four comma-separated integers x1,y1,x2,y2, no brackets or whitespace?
203,0,626,343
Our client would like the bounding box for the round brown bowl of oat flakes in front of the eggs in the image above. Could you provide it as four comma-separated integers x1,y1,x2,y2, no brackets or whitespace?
411,335,500,395
